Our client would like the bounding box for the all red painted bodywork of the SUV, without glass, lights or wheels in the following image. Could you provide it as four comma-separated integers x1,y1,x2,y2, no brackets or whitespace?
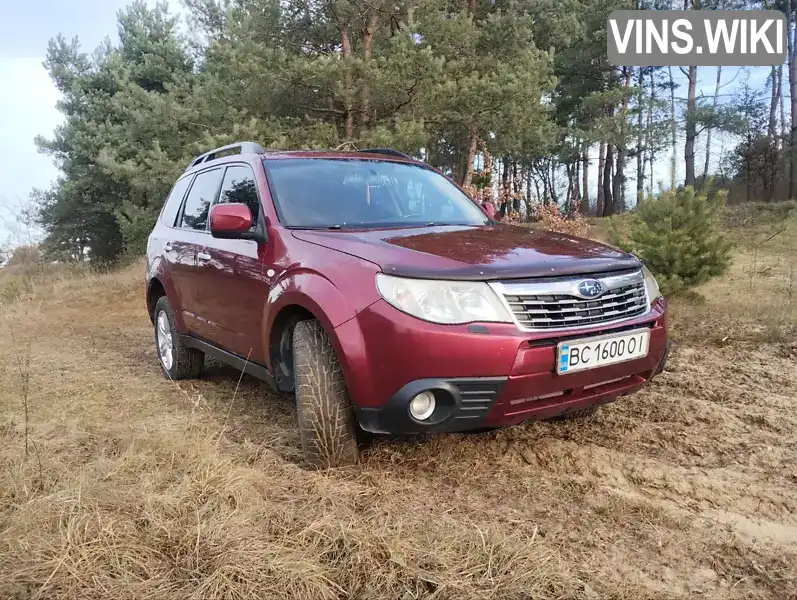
147,152,668,432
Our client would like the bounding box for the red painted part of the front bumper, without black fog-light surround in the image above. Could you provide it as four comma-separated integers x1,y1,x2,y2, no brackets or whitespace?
335,300,667,412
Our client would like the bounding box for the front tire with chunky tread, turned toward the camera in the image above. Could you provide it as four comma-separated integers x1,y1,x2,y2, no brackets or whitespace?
293,320,358,469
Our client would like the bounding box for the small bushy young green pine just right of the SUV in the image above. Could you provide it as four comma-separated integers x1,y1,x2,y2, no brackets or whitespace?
609,187,731,294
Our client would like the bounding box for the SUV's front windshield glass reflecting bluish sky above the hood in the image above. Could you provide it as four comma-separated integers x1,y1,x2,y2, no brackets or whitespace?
265,158,488,229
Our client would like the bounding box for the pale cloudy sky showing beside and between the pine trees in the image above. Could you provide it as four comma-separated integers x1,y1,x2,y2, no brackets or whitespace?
0,0,776,248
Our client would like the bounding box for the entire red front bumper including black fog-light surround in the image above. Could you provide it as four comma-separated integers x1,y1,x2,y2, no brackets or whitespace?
336,300,669,434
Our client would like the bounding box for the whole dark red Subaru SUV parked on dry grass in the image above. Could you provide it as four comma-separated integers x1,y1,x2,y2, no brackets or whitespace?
147,142,668,466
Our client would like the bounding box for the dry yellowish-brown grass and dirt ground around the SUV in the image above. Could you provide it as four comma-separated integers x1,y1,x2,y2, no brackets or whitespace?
0,207,797,600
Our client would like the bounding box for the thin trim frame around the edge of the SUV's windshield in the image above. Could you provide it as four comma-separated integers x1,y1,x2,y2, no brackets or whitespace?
261,156,492,231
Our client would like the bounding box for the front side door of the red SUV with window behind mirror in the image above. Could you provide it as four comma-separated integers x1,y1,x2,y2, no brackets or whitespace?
197,163,268,363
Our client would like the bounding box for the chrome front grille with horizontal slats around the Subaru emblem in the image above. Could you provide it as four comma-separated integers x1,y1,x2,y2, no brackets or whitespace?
496,271,648,330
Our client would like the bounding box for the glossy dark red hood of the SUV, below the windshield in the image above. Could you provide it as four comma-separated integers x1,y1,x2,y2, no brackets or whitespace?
292,224,640,280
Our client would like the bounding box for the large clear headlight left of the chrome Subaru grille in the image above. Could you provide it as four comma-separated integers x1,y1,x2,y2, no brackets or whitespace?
376,273,512,324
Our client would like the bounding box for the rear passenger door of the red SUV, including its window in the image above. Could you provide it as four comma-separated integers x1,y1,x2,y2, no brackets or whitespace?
172,167,224,340
